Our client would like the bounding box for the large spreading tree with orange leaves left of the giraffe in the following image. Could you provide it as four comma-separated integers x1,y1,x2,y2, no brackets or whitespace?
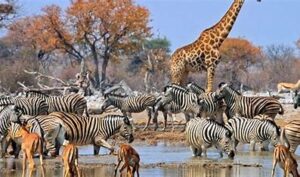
10,0,150,88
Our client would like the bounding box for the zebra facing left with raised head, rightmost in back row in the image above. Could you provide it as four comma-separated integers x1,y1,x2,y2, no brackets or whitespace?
215,83,284,120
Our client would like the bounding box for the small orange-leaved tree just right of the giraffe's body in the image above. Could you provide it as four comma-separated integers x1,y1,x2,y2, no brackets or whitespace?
220,38,262,84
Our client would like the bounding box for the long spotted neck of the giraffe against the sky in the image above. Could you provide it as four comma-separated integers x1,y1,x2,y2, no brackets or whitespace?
199,0,244,48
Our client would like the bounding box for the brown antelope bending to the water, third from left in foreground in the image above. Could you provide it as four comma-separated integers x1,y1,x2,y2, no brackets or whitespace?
115,144,140,177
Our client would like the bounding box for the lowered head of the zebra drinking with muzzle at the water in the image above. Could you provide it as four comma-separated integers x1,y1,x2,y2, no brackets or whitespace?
217,128,235,159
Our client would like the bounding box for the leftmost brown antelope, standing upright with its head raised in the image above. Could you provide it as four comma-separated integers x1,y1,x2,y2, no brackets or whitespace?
16,124,44,176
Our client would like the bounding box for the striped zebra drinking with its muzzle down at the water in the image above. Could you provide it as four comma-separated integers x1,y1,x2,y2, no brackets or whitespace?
185,118,235,158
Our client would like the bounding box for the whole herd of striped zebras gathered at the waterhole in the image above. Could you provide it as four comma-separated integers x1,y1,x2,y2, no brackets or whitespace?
0,83,300,174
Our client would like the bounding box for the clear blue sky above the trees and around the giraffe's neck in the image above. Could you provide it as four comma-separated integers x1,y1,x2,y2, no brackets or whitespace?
12,0,300,51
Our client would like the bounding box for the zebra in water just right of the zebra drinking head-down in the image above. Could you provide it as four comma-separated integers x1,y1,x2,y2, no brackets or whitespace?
225,115,280,151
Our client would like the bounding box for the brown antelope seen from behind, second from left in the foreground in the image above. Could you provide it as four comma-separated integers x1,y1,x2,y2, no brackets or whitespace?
62,144,80,177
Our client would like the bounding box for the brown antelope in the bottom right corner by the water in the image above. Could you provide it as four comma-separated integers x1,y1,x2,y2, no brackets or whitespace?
272,145,300,177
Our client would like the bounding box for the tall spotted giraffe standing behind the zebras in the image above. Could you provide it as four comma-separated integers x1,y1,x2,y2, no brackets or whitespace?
170,0,260,92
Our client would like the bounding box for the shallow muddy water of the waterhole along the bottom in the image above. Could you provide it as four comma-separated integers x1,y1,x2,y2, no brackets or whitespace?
0,143,299,177
